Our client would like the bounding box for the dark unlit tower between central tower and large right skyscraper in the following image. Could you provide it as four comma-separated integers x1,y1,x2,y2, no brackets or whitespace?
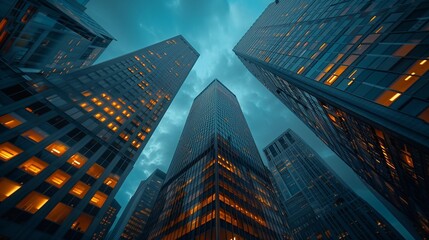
264,130,402,239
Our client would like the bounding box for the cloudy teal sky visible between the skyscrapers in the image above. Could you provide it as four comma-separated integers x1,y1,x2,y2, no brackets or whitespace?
87,0,411,239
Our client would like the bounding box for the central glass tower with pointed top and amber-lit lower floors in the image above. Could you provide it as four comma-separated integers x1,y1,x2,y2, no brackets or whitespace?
143,80,284,240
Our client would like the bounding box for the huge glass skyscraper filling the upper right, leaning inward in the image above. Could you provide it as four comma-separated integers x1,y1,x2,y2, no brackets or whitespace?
234,0,429,235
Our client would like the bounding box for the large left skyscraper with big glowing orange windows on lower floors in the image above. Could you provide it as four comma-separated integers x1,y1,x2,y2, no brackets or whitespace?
0,36,198,239
